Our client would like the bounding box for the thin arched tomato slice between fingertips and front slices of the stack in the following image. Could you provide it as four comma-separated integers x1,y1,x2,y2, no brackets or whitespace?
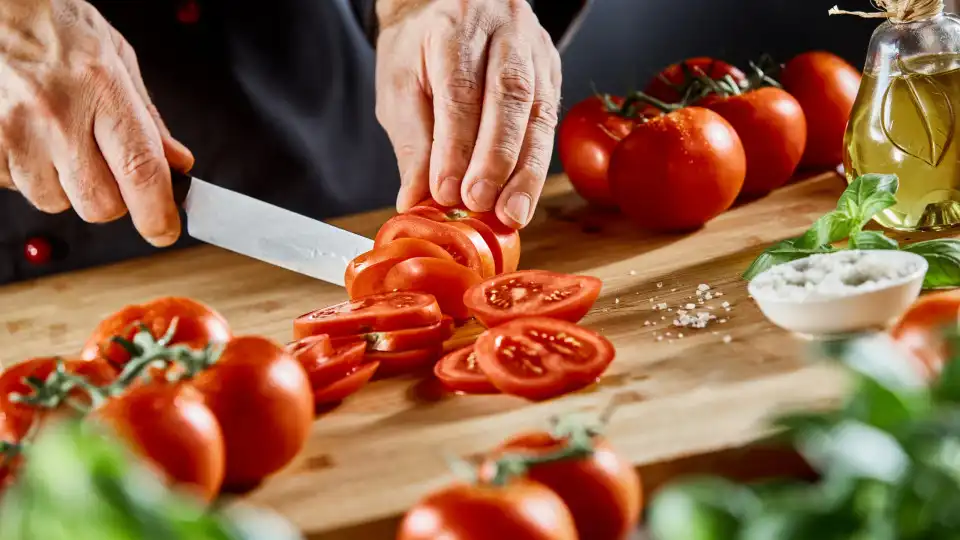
374,214,496,277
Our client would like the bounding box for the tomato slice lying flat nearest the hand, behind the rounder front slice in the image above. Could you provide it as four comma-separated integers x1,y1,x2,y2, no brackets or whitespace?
463,270,603,328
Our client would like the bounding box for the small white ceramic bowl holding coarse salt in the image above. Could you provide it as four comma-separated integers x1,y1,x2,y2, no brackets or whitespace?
747,250,928,336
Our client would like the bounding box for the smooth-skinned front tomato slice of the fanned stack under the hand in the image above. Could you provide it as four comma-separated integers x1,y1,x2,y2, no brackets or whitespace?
383,257,483,321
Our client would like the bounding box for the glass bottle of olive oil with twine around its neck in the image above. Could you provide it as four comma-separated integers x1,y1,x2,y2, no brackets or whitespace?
844,0,960,231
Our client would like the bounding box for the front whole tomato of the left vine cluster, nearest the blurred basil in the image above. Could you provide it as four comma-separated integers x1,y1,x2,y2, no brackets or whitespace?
94,383,225,501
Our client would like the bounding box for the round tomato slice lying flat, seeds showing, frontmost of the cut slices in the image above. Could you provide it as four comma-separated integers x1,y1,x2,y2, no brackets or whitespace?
476,317,614,400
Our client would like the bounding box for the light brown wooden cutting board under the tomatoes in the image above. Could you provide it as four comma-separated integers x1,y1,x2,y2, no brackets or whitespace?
0,173,856,539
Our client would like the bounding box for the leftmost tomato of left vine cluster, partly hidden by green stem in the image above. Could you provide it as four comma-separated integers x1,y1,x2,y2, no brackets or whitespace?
0,358,117,440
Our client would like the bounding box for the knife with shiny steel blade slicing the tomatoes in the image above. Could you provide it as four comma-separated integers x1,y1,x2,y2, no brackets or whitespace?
171,171,373,287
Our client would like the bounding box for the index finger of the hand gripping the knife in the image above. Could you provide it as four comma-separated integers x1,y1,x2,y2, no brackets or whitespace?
93,64,180,247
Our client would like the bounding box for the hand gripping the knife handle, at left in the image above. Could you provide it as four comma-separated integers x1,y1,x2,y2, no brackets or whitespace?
0,0,193,246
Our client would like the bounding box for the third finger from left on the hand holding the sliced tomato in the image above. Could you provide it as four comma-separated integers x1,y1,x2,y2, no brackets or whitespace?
461,27,535,212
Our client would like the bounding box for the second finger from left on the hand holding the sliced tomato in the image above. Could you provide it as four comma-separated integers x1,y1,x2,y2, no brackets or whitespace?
427,25,488,206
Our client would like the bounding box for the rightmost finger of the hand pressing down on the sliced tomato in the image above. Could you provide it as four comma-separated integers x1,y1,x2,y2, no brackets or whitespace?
497,41,562,228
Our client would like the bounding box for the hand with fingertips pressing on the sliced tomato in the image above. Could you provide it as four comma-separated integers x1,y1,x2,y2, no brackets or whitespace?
377,0,560,227
